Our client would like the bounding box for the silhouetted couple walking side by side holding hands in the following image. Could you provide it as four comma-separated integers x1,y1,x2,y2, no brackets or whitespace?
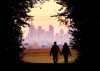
50,42,71,63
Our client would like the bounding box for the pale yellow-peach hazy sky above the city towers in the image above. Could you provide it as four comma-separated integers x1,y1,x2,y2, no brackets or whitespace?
23,0,68,37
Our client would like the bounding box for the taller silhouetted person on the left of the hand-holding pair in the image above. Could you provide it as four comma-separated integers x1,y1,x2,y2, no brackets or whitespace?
50,42,61,63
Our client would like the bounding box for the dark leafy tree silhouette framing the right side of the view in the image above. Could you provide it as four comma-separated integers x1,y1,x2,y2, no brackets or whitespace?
57,0,100,63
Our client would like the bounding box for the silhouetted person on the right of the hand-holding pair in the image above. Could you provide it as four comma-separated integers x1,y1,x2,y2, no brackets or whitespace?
62,43,71,63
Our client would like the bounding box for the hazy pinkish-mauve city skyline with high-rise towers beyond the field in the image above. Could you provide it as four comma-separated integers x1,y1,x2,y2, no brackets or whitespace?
24,22,71,45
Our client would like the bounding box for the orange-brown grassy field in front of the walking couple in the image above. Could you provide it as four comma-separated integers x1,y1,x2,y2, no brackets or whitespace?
23,49,78,63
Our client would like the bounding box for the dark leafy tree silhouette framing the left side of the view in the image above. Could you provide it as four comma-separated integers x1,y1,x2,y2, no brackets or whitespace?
0,0,35,63
